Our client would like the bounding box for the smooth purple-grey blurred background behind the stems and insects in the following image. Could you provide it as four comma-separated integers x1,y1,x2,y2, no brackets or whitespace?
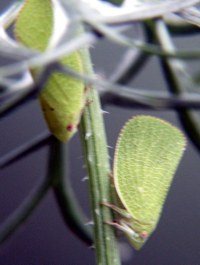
0,0,200,265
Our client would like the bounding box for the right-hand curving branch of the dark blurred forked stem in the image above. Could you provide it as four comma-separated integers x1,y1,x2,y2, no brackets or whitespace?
51,138,93,246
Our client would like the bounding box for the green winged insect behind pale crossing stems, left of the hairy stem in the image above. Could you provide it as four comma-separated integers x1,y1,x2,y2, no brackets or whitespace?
15,0,86,142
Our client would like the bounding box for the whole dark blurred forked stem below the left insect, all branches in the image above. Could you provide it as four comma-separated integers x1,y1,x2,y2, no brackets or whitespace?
0,129,92,245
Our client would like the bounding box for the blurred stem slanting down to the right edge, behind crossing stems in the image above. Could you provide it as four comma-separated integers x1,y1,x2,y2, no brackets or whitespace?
152,20,200,151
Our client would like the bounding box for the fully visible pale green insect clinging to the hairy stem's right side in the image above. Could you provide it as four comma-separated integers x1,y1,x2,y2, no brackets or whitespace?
105,116,186,250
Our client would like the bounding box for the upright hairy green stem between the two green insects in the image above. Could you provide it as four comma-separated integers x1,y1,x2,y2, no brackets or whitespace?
80,50,120,265
